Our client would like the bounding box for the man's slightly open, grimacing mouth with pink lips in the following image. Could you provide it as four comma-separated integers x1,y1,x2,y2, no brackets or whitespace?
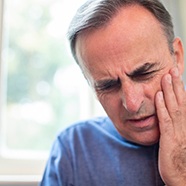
126,114,157,130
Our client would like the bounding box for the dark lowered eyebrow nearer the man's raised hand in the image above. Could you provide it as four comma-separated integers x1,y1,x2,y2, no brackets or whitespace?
127,63,158,77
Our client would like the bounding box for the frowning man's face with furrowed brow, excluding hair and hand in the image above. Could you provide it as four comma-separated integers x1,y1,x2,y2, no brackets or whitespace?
76,6,183,145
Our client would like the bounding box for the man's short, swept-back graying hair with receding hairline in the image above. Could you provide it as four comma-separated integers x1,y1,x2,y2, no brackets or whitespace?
68,0,174,63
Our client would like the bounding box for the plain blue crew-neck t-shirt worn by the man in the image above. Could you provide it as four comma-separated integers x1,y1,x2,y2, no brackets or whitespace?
41,117,164,186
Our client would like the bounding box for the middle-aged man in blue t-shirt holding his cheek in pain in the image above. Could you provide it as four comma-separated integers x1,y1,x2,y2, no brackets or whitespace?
41,0,186,186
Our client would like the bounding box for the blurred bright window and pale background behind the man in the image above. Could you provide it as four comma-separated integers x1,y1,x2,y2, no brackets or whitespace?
0,0,186,185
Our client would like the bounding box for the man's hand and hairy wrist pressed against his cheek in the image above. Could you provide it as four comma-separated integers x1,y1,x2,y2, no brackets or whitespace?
155,67,186,186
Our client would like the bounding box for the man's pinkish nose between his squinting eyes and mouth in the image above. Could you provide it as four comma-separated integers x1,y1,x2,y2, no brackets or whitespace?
121,82,144,113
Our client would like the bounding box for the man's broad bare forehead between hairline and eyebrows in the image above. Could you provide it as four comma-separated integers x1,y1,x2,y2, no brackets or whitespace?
76,5,168,76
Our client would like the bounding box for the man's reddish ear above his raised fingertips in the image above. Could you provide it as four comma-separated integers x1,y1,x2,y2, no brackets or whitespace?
173,38,184,74
